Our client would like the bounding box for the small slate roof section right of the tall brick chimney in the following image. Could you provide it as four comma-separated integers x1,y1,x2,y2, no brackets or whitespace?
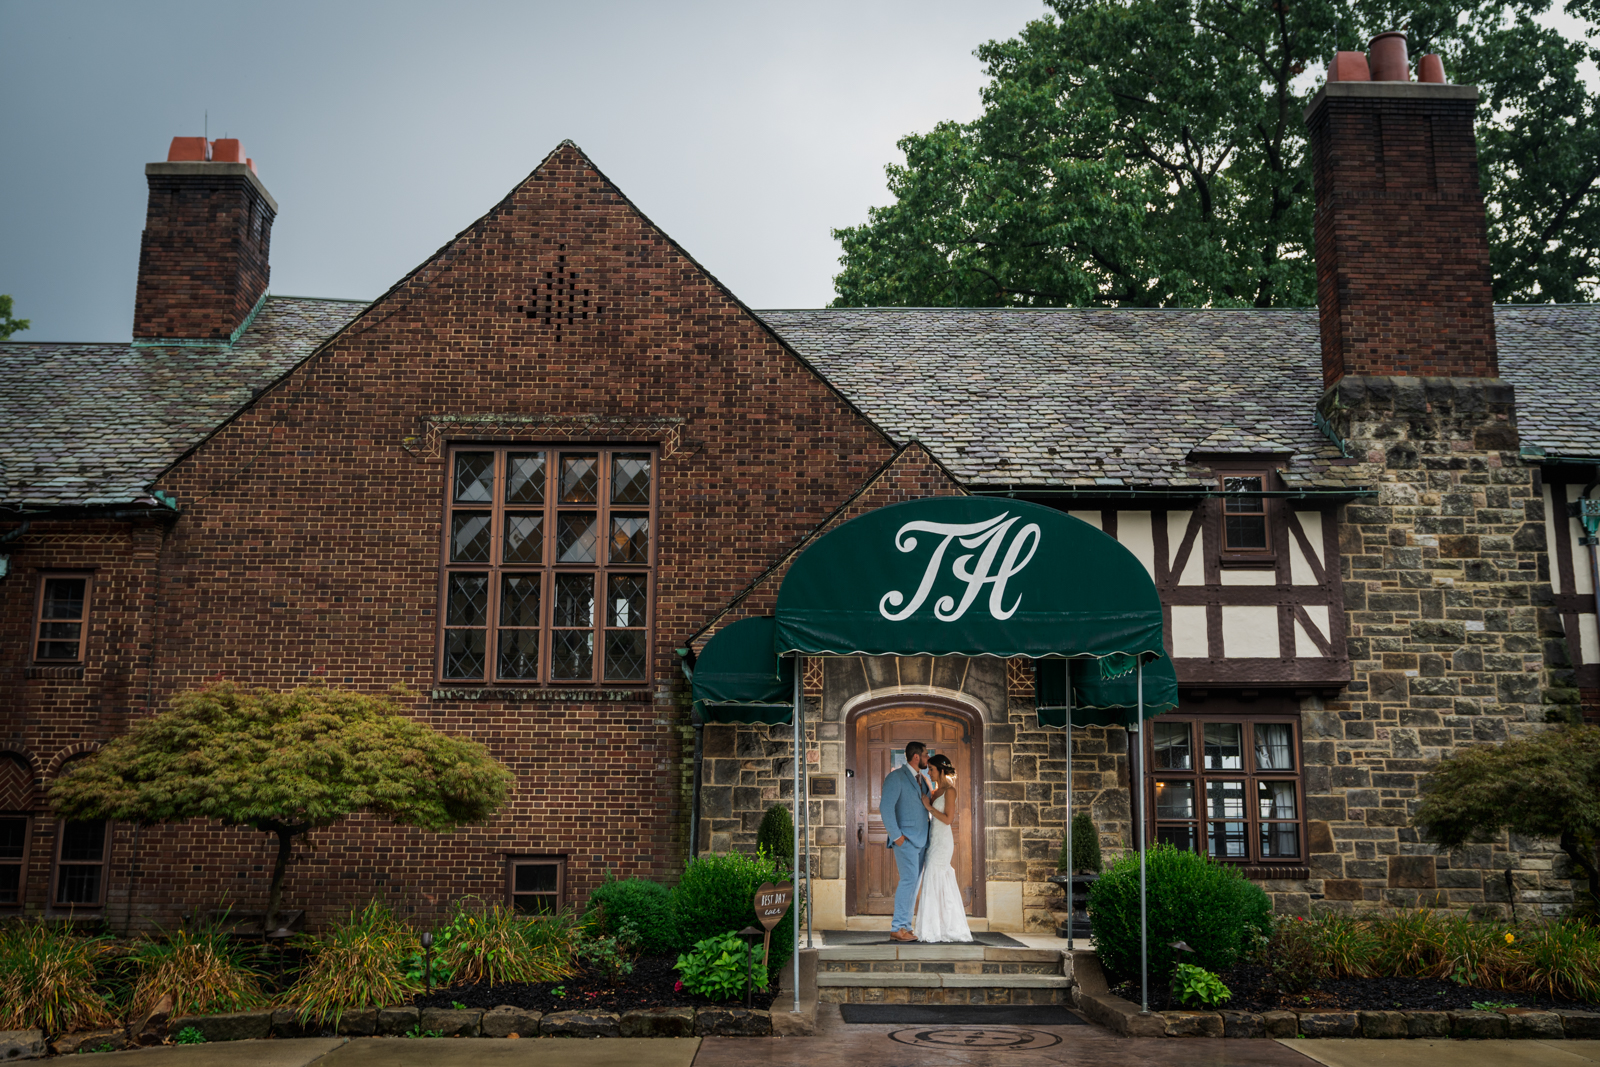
1494,304,1600,458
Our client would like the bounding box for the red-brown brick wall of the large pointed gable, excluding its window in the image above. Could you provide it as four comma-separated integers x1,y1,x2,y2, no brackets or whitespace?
0,144,902,925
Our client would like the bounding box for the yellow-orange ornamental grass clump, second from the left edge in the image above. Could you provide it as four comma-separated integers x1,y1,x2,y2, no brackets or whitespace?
130,912,267,1016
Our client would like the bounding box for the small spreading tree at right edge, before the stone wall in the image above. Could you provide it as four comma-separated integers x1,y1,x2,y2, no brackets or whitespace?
1411,726,1600,912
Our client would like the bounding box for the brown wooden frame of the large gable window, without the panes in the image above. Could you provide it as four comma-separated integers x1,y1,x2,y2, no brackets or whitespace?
435,442,661,689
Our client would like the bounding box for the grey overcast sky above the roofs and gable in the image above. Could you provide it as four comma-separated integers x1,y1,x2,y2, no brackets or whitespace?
0,0,1587,341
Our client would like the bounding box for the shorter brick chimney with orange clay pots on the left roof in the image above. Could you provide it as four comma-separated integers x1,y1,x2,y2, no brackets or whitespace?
133,138,278,342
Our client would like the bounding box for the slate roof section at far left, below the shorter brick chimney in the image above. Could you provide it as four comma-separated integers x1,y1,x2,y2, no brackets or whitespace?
0,296,366,509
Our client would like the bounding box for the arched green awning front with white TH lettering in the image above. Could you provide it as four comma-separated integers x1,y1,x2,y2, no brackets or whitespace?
774,496,1163,659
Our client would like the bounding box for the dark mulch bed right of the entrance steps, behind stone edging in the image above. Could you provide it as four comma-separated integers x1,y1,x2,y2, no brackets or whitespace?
1112,965,1597,1011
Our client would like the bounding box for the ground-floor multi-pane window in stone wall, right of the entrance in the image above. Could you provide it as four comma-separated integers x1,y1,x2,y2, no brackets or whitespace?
1147,715,1306,862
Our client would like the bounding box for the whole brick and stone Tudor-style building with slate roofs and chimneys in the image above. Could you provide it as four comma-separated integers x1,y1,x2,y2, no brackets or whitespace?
0,41,1600,929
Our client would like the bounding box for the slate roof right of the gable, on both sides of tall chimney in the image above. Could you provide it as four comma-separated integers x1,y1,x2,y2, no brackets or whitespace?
757,304,1600,488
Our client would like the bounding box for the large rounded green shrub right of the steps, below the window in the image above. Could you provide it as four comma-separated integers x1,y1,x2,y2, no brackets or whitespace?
1090,845,1272,985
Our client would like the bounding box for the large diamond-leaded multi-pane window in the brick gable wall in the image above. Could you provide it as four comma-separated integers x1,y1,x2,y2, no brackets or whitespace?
440,445,656,685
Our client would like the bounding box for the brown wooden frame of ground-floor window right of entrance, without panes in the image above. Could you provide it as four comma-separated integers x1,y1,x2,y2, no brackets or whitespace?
1141,712,1310,869
